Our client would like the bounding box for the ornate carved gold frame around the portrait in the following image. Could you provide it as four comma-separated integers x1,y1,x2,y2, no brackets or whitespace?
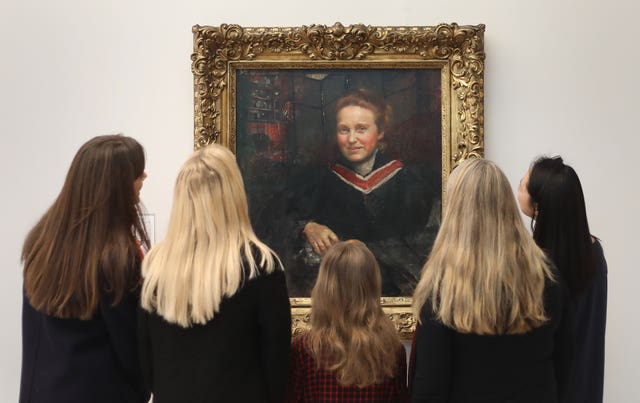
191,23,485,338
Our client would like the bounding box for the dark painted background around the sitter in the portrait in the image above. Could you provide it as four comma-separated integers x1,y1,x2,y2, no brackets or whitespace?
236,69,442,297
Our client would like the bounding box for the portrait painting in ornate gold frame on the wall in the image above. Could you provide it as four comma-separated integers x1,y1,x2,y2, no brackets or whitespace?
192,23,484,337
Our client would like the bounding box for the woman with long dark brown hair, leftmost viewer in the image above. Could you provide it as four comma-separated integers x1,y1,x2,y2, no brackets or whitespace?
20,135,149,403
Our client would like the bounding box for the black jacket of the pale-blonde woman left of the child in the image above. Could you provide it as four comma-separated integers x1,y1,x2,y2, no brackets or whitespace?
139,269,291,403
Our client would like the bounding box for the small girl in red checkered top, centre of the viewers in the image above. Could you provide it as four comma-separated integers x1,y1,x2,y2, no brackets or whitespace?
286,240,407,403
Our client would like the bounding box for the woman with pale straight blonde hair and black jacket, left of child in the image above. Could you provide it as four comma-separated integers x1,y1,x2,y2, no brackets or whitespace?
139,144,291,403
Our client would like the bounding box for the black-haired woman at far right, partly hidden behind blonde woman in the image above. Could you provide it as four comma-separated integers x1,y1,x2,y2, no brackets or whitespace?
518,157,607,403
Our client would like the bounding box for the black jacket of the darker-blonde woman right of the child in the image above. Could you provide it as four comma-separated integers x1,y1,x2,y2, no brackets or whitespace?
409,276,573,403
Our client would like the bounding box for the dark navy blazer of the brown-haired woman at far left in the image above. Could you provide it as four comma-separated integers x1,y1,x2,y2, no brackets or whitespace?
19,291,149,403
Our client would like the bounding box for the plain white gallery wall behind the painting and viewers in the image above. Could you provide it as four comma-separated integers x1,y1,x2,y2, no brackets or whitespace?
0,0,640,402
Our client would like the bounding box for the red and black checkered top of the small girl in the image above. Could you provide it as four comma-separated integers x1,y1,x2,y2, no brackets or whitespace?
287,337,409,403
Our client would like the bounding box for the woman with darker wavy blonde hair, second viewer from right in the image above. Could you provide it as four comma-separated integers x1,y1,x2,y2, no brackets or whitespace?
410,159,572,403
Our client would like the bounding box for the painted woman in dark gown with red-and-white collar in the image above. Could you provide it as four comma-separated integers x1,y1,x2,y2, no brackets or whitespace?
288,89,441,296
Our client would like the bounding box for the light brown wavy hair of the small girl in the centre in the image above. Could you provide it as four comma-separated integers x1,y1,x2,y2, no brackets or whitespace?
304,240,402,387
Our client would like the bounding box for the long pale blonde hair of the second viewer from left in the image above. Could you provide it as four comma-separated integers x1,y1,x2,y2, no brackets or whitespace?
141,144,281,327
